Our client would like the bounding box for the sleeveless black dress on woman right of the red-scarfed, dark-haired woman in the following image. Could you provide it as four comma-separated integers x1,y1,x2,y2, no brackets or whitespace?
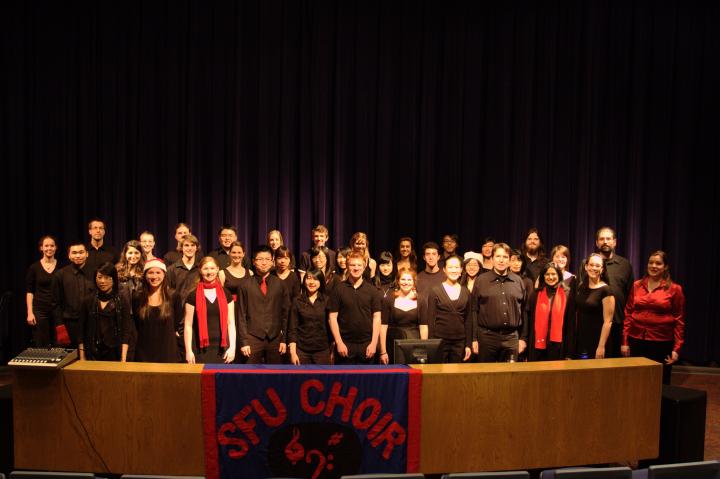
575,285,612,359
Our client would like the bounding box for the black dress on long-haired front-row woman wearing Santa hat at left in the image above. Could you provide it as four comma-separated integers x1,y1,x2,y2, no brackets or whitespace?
133,296,178,363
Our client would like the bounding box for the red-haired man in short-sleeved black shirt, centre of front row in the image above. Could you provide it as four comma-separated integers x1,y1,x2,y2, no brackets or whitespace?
328,251,382,364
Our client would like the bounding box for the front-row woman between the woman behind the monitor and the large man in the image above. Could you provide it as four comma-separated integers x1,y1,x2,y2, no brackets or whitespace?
426,256,473,363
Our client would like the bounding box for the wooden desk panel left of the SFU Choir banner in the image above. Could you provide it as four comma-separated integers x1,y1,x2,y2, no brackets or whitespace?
13,361,205,475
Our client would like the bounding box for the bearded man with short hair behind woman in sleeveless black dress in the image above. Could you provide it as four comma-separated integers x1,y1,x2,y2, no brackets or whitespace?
578,226,634,358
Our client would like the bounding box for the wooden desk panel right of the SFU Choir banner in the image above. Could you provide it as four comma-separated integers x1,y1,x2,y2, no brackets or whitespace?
420,358,662,473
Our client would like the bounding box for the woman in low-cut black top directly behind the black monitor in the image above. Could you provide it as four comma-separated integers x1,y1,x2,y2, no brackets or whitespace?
380,268,428,364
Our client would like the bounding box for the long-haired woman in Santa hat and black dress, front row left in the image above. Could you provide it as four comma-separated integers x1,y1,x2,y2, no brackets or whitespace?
133,258,180,363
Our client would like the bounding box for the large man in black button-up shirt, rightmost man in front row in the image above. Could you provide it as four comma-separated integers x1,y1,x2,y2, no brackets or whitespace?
473,243,527,362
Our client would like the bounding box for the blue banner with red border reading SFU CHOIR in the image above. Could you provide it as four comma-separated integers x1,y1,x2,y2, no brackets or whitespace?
202,365,421,479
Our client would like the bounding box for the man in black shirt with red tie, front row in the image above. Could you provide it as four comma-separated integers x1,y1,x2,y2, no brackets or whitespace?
238,246,290,364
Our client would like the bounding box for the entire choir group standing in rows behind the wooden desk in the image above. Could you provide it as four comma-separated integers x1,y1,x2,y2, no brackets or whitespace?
26,219,685,382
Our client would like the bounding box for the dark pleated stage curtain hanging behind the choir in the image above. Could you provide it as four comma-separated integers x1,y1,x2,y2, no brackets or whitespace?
0,0,720,362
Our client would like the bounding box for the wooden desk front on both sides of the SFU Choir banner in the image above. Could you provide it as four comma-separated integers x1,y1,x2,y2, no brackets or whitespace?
13,358,662,475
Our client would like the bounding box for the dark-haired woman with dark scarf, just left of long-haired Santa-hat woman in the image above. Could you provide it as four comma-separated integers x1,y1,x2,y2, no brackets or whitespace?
78,263,132,362
